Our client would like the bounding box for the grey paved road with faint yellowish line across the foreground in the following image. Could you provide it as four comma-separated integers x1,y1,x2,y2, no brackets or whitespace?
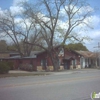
0,70,100,100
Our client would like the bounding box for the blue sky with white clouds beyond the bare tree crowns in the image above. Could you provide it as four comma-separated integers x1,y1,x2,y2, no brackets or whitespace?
0,0,100,51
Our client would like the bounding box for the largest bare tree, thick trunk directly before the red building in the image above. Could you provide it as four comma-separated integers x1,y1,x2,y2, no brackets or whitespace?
24,0,91,70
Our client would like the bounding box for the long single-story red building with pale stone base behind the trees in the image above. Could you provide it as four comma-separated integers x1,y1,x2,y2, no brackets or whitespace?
0,48,97,71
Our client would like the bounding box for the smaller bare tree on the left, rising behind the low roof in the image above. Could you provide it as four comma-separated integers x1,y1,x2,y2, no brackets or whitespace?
0,10,39,57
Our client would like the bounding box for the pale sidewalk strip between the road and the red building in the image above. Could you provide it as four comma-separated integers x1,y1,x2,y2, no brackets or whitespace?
0,69,100,78
